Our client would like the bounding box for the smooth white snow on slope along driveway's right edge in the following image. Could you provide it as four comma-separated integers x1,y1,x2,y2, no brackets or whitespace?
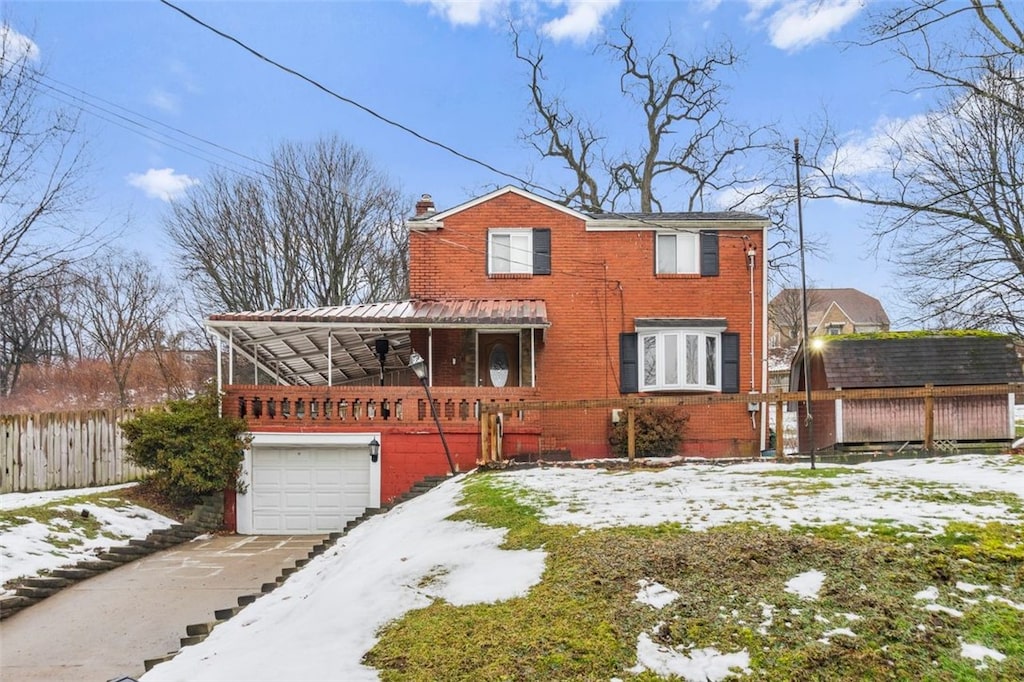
143,477,546,682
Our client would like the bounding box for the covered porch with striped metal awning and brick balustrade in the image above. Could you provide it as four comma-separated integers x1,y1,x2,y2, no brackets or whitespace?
206,299,550,430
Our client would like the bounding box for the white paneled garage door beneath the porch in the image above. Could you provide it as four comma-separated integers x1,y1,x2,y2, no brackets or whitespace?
249,445,371,535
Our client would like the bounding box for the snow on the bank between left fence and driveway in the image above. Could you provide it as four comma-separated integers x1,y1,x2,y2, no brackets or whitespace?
0,483,174,596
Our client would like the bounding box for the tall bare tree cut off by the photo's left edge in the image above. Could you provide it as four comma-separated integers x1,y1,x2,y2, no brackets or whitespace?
0,22,97,396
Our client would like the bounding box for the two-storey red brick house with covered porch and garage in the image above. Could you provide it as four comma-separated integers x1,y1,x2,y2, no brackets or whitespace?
207,186,768,532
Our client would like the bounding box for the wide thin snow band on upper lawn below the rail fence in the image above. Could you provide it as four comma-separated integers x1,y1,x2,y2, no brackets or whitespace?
493,455,1024,532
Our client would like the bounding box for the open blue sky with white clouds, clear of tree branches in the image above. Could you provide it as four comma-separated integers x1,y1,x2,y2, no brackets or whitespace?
3,0,927,321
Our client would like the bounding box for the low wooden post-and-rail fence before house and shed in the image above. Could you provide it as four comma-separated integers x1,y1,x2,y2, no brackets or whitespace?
480,383,1024,463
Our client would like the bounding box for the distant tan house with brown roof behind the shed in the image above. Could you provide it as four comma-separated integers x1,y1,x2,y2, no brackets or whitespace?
768,289,889,348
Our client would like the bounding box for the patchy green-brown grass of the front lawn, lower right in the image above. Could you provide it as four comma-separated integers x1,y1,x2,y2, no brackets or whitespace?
366,469,1024,682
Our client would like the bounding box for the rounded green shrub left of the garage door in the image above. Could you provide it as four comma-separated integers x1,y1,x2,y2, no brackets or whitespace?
121,390,248,504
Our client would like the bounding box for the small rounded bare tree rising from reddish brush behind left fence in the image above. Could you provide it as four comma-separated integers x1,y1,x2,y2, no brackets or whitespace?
75,252,172,406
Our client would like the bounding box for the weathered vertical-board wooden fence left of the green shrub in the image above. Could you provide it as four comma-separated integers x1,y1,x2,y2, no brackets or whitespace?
0,409,145,493
